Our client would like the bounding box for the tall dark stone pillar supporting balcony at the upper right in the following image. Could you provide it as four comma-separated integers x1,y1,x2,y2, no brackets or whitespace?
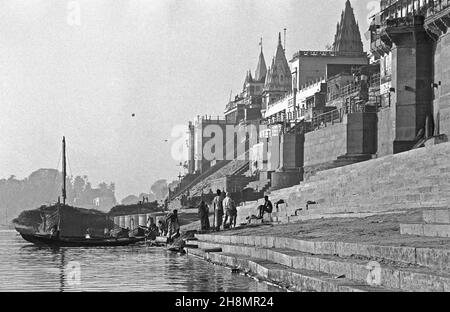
386,16,433,153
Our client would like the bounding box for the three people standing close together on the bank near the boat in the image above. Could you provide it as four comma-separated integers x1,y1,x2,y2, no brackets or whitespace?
199,190,237,231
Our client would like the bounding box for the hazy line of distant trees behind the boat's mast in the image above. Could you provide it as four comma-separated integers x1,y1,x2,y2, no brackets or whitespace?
0,169,169,224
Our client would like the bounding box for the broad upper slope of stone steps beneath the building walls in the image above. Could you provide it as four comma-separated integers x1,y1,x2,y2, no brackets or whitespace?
238,142,450,227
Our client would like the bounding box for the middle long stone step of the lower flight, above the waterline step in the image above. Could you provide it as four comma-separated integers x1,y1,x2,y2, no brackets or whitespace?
199,242,450,292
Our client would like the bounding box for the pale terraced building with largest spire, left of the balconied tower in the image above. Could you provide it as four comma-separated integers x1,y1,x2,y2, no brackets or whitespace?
251,1,376,188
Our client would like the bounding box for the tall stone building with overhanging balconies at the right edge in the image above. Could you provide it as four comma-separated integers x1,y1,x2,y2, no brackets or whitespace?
370,0,450,156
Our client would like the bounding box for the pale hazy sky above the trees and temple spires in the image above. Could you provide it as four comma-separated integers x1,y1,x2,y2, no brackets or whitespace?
0,0,379,199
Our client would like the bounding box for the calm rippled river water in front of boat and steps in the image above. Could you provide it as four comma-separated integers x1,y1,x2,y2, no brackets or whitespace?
0,230,281,292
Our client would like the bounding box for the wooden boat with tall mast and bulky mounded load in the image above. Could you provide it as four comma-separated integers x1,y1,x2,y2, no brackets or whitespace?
15,137,145,247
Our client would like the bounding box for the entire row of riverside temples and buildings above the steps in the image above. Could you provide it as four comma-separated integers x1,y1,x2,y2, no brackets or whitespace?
170,0,450,207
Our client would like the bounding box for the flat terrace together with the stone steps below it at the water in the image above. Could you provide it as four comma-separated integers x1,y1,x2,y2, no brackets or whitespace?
188,209,450,291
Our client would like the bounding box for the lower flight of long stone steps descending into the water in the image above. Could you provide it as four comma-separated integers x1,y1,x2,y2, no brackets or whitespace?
188,234,450,292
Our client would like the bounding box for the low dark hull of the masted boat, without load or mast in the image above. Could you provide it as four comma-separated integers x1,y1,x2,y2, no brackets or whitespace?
19,232,145,247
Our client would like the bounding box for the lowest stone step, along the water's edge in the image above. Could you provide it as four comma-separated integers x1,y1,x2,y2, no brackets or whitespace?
188,249,394,292
